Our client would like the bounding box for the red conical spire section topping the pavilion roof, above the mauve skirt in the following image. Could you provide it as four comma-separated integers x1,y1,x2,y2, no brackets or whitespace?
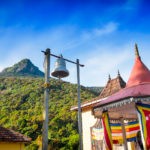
126,45,150,87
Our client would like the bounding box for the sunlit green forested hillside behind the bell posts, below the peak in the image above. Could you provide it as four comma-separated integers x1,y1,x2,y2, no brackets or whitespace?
0,77,95,150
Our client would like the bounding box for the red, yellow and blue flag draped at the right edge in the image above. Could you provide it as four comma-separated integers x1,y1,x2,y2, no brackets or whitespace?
136,103,150,150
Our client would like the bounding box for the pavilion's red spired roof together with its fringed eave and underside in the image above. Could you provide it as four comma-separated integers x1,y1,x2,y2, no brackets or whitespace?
94,44,150,118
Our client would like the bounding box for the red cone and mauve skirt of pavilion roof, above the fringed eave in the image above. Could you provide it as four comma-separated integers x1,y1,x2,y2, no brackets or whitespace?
96,45,150,107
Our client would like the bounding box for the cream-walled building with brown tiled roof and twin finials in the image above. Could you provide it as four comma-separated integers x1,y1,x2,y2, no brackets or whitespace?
71,66,126,150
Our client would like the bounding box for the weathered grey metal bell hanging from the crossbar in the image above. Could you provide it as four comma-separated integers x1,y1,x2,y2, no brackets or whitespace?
51,55,69,79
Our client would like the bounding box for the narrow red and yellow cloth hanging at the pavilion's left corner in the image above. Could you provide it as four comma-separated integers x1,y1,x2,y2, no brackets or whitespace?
102,111,113,150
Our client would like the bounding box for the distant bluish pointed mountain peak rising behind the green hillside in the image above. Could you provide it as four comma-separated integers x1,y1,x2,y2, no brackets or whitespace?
0,59,44,77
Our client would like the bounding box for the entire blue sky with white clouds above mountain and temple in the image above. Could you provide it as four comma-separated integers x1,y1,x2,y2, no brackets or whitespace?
0,0,150,86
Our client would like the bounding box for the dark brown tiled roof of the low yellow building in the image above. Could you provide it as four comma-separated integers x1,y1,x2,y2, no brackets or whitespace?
0,126,31,143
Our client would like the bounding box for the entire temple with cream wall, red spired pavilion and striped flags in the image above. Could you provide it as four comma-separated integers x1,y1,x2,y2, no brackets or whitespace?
72,44,150,150
